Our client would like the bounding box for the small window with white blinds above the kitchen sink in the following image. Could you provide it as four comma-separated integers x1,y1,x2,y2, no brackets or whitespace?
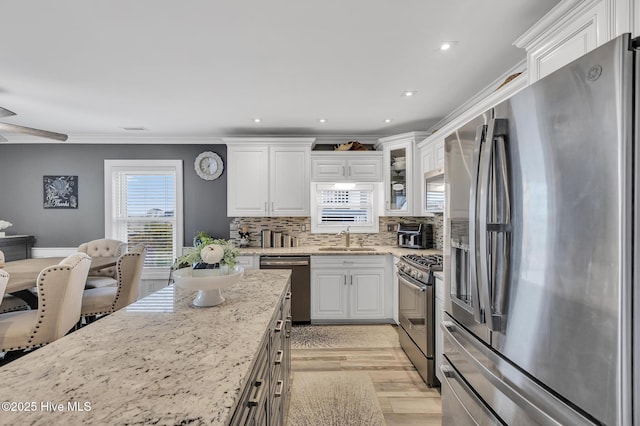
311,183,378,233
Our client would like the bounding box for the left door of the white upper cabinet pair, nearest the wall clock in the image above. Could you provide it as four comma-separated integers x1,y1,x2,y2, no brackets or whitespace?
227,146,269,217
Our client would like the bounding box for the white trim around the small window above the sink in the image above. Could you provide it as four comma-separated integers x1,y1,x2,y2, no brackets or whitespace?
310,182,380,234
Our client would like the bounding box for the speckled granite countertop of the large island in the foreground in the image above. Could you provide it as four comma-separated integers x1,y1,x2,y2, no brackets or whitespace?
0,270,291,425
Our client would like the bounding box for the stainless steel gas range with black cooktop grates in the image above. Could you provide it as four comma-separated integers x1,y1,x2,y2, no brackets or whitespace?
397,254,442,386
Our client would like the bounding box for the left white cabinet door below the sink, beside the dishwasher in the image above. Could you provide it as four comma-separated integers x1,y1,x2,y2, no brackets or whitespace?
311,270,348,321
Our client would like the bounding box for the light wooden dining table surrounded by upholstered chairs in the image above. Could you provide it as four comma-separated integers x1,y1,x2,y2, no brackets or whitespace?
3,256,118,308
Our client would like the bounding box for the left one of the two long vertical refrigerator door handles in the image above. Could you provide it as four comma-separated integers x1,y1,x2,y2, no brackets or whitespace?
468,124,487,324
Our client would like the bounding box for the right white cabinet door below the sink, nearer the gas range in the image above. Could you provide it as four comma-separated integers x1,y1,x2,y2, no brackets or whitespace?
348,268,384,319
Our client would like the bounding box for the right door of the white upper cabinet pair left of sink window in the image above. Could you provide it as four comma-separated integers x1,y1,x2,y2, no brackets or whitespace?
269,147,310,216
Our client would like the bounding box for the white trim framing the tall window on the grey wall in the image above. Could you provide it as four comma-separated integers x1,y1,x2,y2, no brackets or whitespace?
104,160,184,279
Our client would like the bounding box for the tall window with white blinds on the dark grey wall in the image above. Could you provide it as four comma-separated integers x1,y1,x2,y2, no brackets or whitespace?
105,160,182,268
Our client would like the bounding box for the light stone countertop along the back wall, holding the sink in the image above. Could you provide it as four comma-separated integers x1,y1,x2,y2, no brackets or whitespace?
240,246,442,257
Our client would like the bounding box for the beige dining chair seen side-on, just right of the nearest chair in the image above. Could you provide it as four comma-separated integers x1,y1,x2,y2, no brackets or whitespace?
81,245,147,324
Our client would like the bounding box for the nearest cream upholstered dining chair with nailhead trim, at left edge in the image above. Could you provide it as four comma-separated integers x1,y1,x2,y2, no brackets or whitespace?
0,253,91,352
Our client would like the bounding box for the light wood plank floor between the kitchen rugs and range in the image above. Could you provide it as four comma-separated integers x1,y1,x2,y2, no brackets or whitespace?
291,326,440,426
